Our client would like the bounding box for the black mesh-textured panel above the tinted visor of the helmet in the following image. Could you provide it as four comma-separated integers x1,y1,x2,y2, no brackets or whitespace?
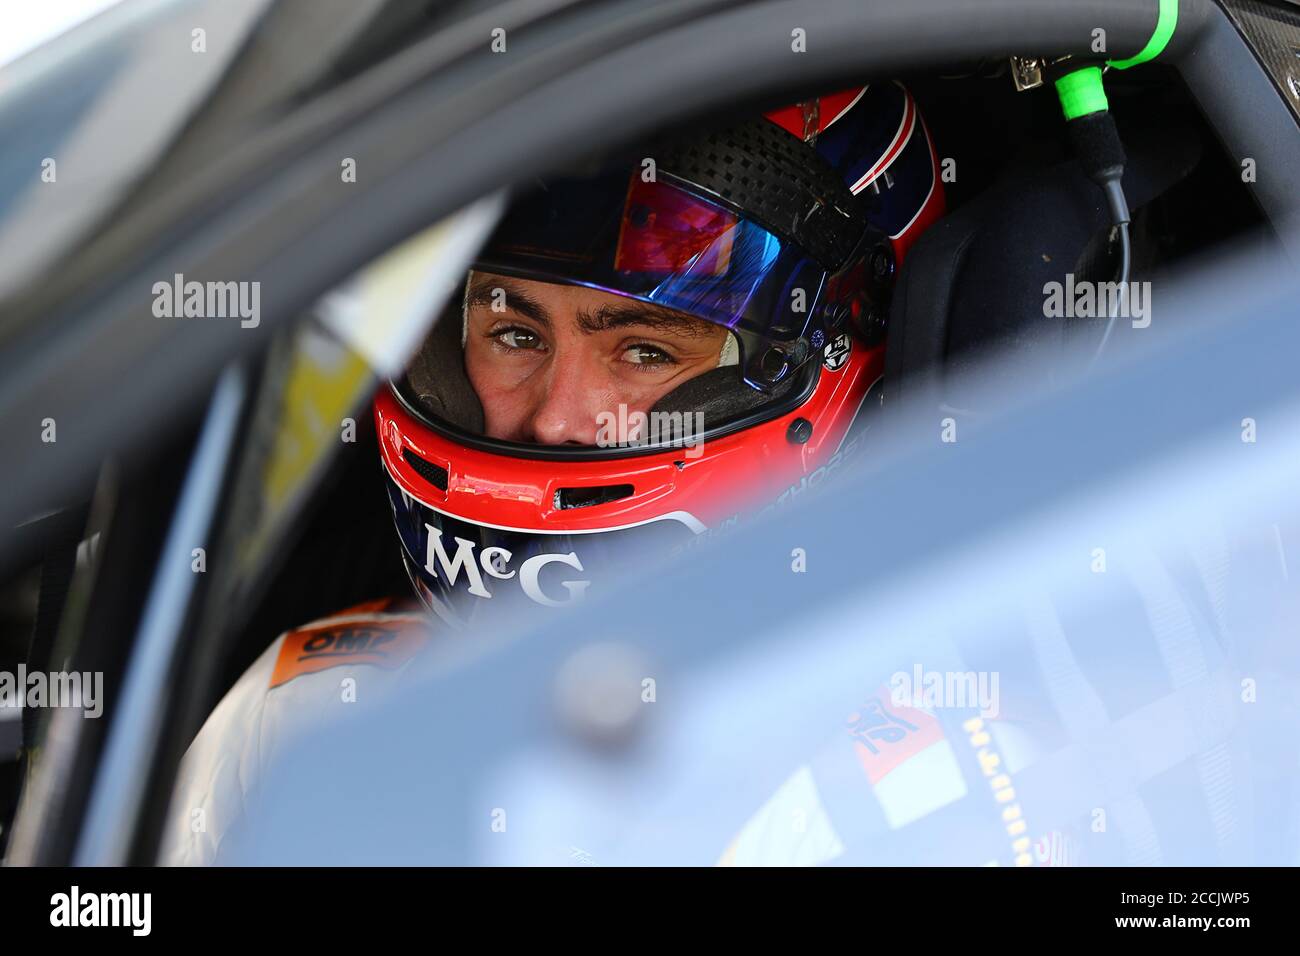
654,117,867,272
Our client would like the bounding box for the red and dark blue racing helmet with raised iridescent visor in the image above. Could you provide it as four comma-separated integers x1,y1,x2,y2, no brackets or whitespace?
374,83,944,622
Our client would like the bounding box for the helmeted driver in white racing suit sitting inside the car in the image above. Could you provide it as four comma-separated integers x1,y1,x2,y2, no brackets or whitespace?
161,83,944,864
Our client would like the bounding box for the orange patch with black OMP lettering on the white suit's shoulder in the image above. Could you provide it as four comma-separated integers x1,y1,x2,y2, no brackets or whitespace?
270,615,428,687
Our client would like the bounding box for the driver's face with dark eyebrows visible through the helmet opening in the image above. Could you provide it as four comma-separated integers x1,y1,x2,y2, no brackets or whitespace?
465,272,727,445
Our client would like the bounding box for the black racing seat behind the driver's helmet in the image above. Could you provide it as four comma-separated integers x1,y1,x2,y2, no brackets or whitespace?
881,129,1203,410
